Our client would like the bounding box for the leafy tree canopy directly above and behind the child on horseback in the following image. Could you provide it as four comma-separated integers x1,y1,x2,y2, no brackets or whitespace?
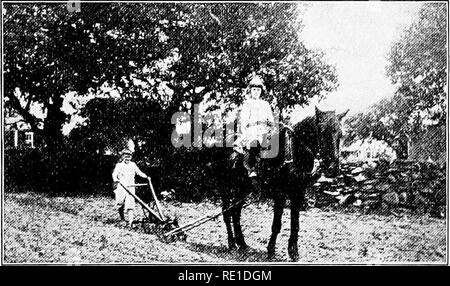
163,3,337,111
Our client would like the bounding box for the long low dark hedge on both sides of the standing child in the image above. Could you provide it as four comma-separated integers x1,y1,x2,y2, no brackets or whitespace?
5,145,225,202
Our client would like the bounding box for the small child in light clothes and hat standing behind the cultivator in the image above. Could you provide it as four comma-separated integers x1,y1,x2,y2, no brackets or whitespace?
112,150,148,227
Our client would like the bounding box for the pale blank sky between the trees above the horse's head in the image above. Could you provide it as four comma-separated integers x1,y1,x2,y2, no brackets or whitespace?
292,1,421,120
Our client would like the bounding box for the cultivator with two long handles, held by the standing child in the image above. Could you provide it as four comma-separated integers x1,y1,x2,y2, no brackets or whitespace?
119,181,186,241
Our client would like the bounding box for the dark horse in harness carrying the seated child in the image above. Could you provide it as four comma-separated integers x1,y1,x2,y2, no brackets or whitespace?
213,108,347,261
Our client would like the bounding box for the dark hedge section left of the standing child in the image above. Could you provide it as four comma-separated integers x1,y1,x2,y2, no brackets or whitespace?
5,147,117,194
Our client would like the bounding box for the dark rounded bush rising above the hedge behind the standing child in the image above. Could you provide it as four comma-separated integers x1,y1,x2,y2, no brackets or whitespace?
69,98,171,154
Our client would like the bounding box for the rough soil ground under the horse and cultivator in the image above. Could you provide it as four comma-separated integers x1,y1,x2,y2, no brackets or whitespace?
3,193,447,264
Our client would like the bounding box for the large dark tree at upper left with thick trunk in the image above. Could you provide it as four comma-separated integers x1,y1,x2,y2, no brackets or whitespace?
4,3,179,149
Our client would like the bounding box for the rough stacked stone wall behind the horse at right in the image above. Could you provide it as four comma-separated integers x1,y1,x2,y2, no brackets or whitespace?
307,160,446,218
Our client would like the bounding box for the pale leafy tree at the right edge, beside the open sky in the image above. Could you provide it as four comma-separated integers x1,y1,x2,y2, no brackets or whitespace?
387,3,447,124
